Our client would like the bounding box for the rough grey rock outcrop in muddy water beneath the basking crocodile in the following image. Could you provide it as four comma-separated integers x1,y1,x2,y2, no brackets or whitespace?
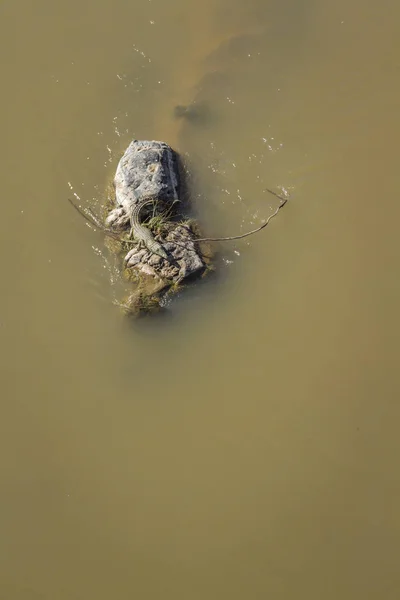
106,140,205,312
